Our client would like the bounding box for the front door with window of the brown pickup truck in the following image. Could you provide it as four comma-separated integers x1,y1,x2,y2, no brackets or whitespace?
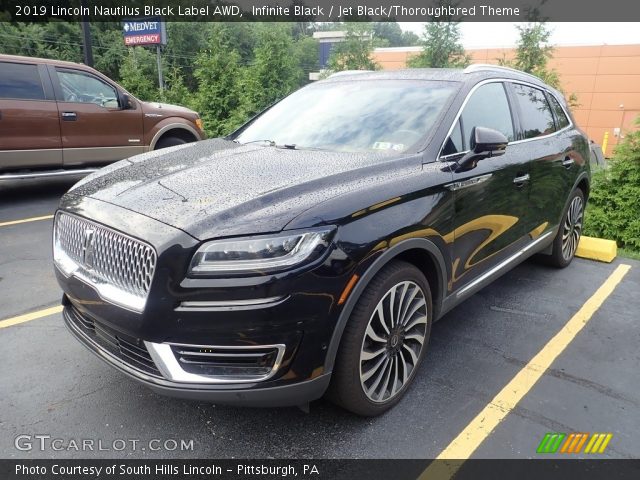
50,67,145,167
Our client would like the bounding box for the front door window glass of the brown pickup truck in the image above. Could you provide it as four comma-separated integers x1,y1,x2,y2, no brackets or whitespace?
56,69,119,108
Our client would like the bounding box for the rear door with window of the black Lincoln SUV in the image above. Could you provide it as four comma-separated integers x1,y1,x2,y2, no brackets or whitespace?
510,83,578,234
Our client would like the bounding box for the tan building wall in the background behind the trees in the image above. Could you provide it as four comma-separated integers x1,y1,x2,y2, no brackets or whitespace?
374,44,640,156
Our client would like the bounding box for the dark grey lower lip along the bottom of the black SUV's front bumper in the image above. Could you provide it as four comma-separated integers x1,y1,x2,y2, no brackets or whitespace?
63,302,331,407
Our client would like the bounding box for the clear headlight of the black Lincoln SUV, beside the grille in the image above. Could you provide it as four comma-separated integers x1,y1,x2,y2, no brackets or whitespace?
189,228,333,275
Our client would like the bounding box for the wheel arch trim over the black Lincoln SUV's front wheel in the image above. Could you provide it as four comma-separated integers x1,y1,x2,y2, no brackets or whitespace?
324,238,447,372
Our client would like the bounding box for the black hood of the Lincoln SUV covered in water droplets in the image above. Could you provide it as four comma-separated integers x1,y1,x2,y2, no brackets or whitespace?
71,139,420,240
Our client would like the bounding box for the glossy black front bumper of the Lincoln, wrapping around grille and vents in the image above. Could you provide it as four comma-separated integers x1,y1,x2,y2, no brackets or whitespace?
55,196,356,405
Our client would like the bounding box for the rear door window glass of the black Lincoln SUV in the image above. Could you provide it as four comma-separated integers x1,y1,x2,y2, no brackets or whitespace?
512,83,556,139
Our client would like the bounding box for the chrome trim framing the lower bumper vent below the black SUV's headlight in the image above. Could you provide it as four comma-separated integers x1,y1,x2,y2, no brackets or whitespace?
144,340,285,385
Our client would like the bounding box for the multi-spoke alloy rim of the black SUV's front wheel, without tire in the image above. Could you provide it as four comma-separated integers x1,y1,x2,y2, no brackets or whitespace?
360,281,428,403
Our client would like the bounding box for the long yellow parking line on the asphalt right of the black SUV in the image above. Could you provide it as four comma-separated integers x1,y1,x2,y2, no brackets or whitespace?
419,265,631,480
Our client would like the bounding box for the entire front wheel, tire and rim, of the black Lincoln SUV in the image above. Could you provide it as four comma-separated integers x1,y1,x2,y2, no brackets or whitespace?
327,260,433,416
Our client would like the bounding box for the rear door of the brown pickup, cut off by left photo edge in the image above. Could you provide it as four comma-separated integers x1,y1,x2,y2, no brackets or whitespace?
0,61,62,171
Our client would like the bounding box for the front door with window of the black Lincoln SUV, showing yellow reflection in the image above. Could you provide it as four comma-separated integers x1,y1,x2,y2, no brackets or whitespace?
441,81,530,292
